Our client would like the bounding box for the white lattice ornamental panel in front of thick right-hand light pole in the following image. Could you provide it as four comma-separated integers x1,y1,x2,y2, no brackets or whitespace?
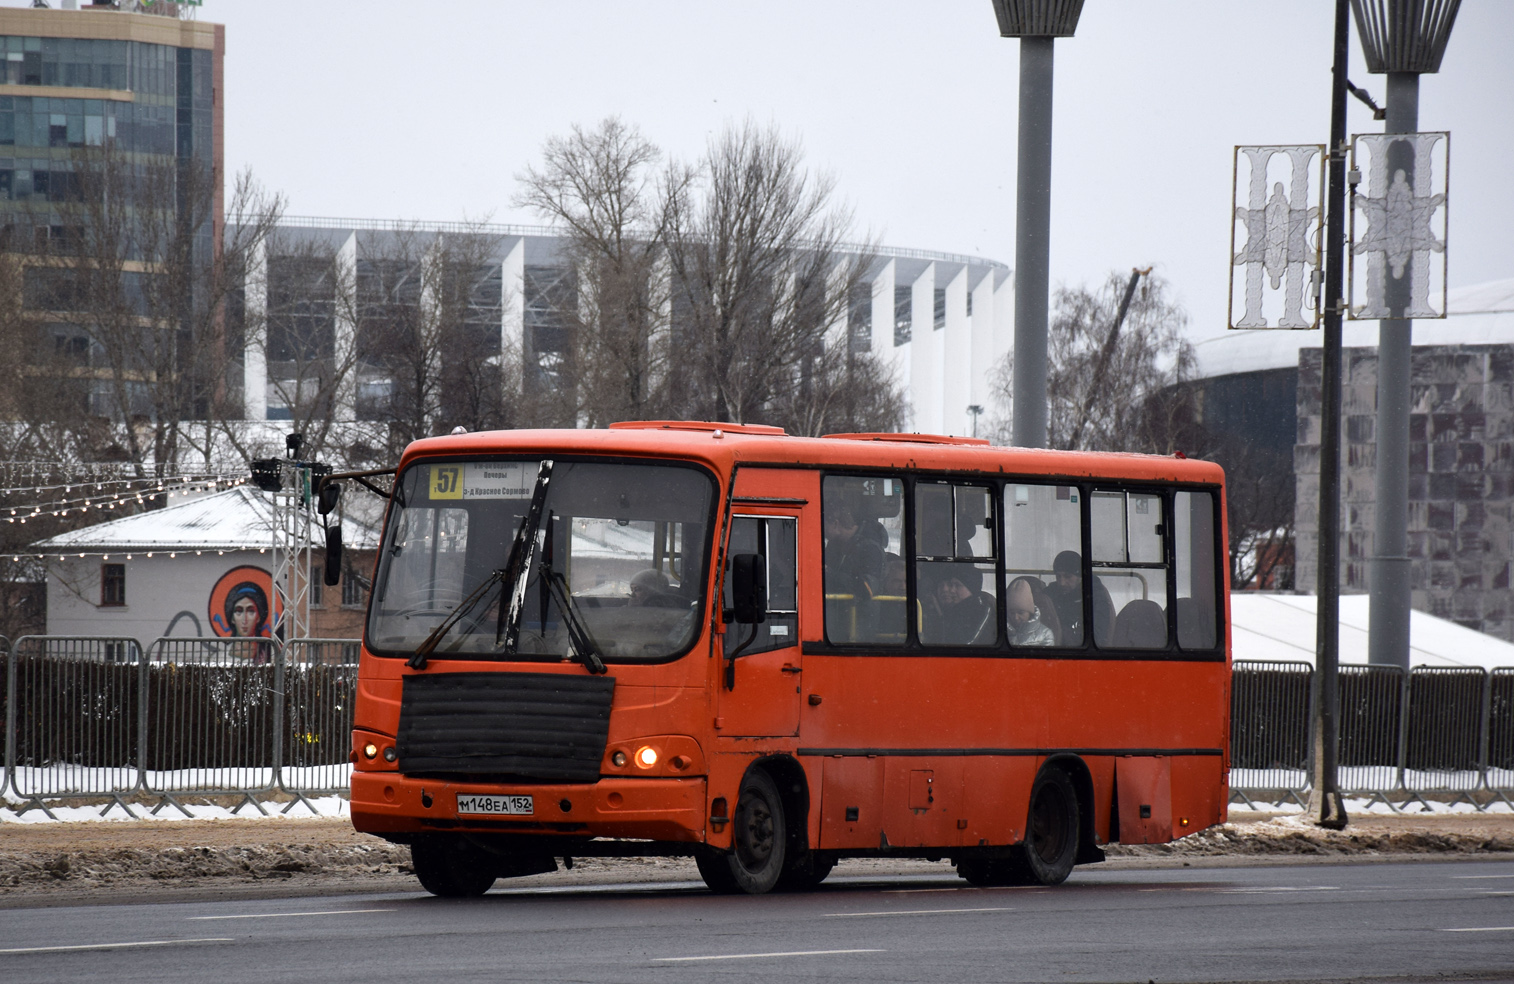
1347,132,1450,321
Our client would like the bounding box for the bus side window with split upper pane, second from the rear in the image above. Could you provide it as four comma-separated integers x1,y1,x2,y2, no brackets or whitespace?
1090,490,1167,649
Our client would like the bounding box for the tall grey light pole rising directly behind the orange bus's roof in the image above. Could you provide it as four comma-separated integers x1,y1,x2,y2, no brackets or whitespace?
993,0,1083,448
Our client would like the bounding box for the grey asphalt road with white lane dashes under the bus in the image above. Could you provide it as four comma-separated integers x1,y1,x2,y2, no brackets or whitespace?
0,861,1514,984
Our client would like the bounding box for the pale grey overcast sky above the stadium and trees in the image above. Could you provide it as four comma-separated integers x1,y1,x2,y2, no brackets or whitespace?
174,0,1514,341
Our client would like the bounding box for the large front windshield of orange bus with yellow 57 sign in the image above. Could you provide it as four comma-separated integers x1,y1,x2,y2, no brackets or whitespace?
368,459,715,660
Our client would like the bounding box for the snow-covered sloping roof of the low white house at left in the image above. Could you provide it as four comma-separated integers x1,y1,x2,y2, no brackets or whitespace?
32,486,379,553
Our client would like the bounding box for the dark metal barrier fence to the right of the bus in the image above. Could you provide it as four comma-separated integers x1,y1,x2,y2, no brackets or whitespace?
1231,660,1514,810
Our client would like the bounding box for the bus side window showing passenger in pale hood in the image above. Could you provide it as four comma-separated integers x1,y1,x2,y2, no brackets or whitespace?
1004,483,1086,648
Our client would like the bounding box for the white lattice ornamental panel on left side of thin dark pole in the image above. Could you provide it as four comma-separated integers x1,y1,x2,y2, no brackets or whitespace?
1229,144,1325,329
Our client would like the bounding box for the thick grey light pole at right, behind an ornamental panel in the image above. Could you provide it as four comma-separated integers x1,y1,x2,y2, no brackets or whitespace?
1350,0,1461,671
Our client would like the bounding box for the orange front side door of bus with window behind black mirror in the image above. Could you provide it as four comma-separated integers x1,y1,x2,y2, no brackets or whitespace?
718,509,802,737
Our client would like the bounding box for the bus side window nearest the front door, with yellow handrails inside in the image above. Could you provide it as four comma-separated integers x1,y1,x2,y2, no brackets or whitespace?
821,475,908,646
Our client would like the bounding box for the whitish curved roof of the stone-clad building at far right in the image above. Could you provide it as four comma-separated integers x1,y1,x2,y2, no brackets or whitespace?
1193,277,1514,378
